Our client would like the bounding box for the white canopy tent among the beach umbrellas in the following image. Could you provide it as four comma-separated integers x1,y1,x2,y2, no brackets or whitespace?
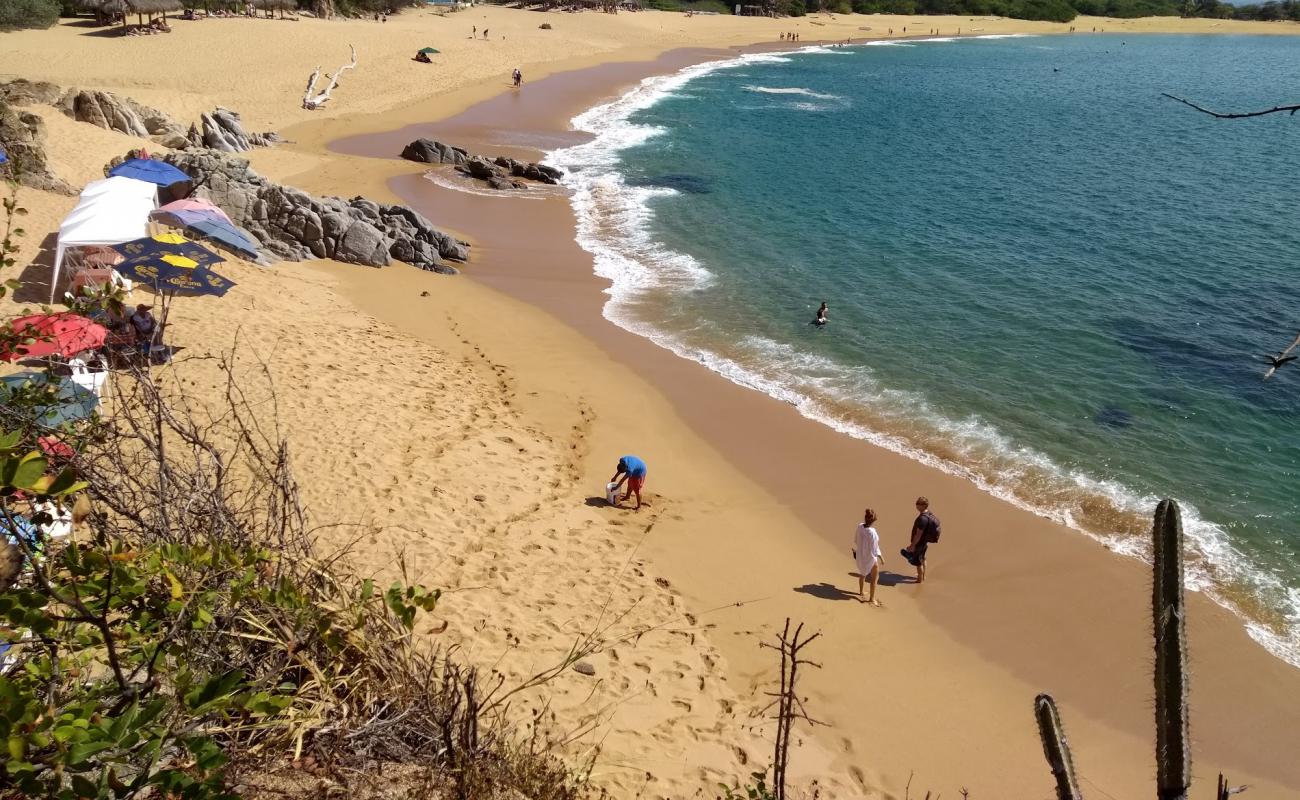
49,176,159,303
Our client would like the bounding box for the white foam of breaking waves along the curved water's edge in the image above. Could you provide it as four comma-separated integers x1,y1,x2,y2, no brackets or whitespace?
546,43,1300,667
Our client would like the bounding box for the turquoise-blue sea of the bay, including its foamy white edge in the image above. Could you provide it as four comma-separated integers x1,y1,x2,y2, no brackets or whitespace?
549,34,1300,666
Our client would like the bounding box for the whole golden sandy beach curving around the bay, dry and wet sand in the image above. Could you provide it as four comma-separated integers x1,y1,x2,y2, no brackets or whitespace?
0,8,1300,797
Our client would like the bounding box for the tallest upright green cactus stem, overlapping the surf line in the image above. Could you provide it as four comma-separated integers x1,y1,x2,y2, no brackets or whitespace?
1151,500,1192,800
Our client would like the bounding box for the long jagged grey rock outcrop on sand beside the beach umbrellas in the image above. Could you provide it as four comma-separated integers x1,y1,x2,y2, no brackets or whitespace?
164,150,468,273
